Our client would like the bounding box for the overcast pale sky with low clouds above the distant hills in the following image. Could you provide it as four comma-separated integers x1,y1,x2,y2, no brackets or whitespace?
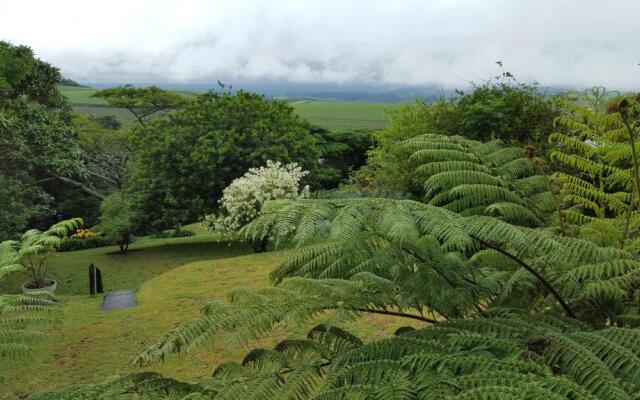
0,0,640,90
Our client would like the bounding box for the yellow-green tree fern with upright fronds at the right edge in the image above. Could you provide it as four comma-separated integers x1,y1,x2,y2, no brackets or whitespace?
549,88,640,246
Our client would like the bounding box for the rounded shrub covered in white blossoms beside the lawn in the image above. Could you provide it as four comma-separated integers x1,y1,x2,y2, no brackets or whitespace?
202,161,309,232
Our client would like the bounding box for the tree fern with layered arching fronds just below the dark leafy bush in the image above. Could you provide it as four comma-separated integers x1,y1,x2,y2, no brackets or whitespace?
405,134,549,226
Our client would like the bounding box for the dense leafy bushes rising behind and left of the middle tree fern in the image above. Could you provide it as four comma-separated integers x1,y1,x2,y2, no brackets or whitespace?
357,72,559,195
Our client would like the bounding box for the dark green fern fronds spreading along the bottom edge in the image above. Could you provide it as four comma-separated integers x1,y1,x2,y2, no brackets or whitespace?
50,315,640,400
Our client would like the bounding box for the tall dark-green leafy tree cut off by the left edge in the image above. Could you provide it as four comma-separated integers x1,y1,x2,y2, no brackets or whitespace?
0,42,81,238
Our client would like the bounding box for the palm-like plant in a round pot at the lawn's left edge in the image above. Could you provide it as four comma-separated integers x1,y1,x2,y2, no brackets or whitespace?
0,218,83,289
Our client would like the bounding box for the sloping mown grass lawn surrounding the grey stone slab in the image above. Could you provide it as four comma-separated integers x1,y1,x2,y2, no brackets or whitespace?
0,235,422,399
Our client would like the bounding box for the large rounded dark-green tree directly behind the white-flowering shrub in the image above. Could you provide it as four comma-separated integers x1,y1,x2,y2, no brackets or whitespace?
130,91,319,229
